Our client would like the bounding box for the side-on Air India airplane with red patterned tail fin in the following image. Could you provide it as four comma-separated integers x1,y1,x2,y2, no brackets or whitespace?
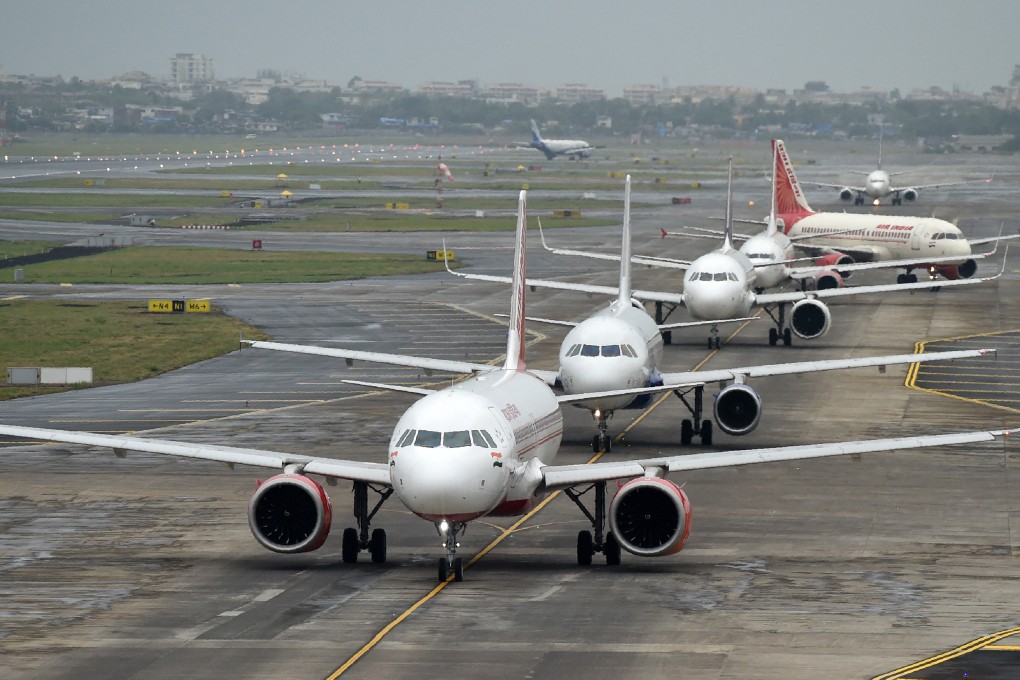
772,140,1017,283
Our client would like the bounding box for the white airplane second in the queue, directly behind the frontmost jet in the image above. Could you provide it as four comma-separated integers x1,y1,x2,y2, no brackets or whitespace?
444,175,995,453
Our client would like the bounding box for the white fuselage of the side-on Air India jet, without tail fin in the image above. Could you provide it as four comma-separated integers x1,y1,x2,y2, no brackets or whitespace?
780,212,971,264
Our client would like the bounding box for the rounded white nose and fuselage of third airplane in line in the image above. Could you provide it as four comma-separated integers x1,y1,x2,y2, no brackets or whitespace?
683,249,757,321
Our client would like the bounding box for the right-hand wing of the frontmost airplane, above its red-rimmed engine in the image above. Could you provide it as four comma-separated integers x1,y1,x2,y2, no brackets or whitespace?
542,429,1013,490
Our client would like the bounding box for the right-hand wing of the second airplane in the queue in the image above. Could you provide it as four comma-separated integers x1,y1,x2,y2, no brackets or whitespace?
662,349,996,383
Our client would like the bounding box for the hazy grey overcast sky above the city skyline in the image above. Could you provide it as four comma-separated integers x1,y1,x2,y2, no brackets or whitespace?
0,0,1020,97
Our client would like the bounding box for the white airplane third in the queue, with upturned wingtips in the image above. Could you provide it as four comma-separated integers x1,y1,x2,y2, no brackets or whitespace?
469,160,1006,349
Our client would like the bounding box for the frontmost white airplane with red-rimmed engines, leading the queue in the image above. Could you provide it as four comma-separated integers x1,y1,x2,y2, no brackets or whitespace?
0,192,1011,582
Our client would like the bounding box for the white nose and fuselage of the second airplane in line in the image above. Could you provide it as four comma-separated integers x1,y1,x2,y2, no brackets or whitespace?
560,300,662,413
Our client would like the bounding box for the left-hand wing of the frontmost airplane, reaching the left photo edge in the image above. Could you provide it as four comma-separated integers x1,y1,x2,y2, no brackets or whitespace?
0,425,390,486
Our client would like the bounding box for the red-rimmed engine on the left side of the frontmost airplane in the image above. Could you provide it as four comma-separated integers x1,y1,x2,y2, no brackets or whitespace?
248,474,333,554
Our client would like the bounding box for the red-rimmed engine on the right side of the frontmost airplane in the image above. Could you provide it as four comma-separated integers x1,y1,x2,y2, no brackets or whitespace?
609,477,691,558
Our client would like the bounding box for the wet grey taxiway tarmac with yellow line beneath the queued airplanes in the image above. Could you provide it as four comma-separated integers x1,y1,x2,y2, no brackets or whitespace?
0,142,1020,680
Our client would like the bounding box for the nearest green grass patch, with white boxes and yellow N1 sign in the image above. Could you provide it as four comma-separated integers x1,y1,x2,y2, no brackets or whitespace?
0,300,268,399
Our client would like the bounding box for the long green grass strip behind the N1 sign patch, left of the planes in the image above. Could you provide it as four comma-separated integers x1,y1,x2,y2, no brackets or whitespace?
0,244,443,284
